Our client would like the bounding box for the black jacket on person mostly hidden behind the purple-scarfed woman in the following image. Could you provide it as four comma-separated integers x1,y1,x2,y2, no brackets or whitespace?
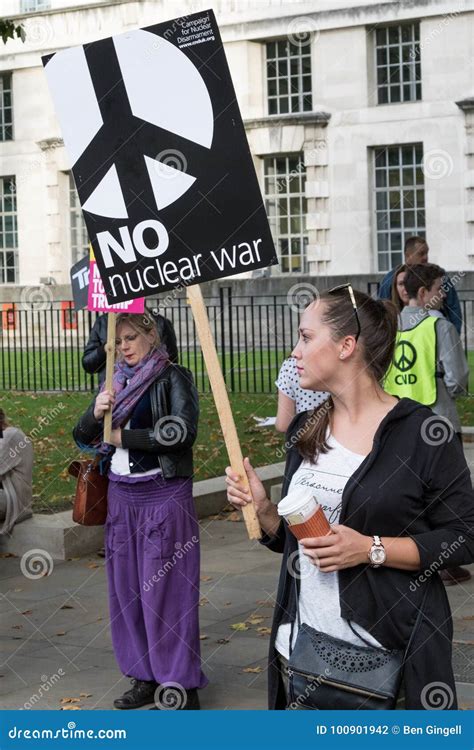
82,313,178,383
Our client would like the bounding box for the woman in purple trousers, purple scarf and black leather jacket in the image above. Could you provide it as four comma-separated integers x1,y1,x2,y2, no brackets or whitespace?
74,312,207,710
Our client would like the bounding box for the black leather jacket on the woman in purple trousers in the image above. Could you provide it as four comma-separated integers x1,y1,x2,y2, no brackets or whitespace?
73,364,199,479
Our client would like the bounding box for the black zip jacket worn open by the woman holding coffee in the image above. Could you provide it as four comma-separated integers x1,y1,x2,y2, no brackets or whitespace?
262,399,474,709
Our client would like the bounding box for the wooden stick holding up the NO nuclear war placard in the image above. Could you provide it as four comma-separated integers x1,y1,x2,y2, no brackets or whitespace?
187,284,262,539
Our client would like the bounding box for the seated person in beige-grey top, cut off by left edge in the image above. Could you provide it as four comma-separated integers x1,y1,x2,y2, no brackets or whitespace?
0,408,33,534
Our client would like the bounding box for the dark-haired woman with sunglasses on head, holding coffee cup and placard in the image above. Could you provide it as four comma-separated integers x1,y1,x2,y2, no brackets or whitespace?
227,285,474,709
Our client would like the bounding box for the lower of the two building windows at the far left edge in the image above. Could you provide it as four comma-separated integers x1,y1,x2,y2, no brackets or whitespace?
0,177,18,284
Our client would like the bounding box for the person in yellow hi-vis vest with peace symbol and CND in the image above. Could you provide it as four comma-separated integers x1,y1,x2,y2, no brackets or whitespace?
384,263,470,585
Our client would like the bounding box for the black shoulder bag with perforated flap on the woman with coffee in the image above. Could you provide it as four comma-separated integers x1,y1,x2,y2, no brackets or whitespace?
288,579,429,710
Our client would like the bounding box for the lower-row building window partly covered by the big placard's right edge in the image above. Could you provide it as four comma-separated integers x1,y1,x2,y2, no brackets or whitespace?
264,154,308,273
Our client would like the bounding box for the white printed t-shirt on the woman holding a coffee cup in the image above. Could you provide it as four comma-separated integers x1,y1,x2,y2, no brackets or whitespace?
275,435,381,659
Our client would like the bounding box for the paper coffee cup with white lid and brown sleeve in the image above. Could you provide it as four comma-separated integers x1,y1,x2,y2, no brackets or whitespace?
278,487,331,539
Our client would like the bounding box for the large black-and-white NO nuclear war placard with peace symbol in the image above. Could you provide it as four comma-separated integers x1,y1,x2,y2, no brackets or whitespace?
43,10,277,303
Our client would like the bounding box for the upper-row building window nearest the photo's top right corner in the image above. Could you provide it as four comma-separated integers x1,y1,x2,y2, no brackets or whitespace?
375,23,421,104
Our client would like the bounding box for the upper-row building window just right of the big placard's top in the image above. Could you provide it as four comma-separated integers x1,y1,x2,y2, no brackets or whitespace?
267,40,313,115
